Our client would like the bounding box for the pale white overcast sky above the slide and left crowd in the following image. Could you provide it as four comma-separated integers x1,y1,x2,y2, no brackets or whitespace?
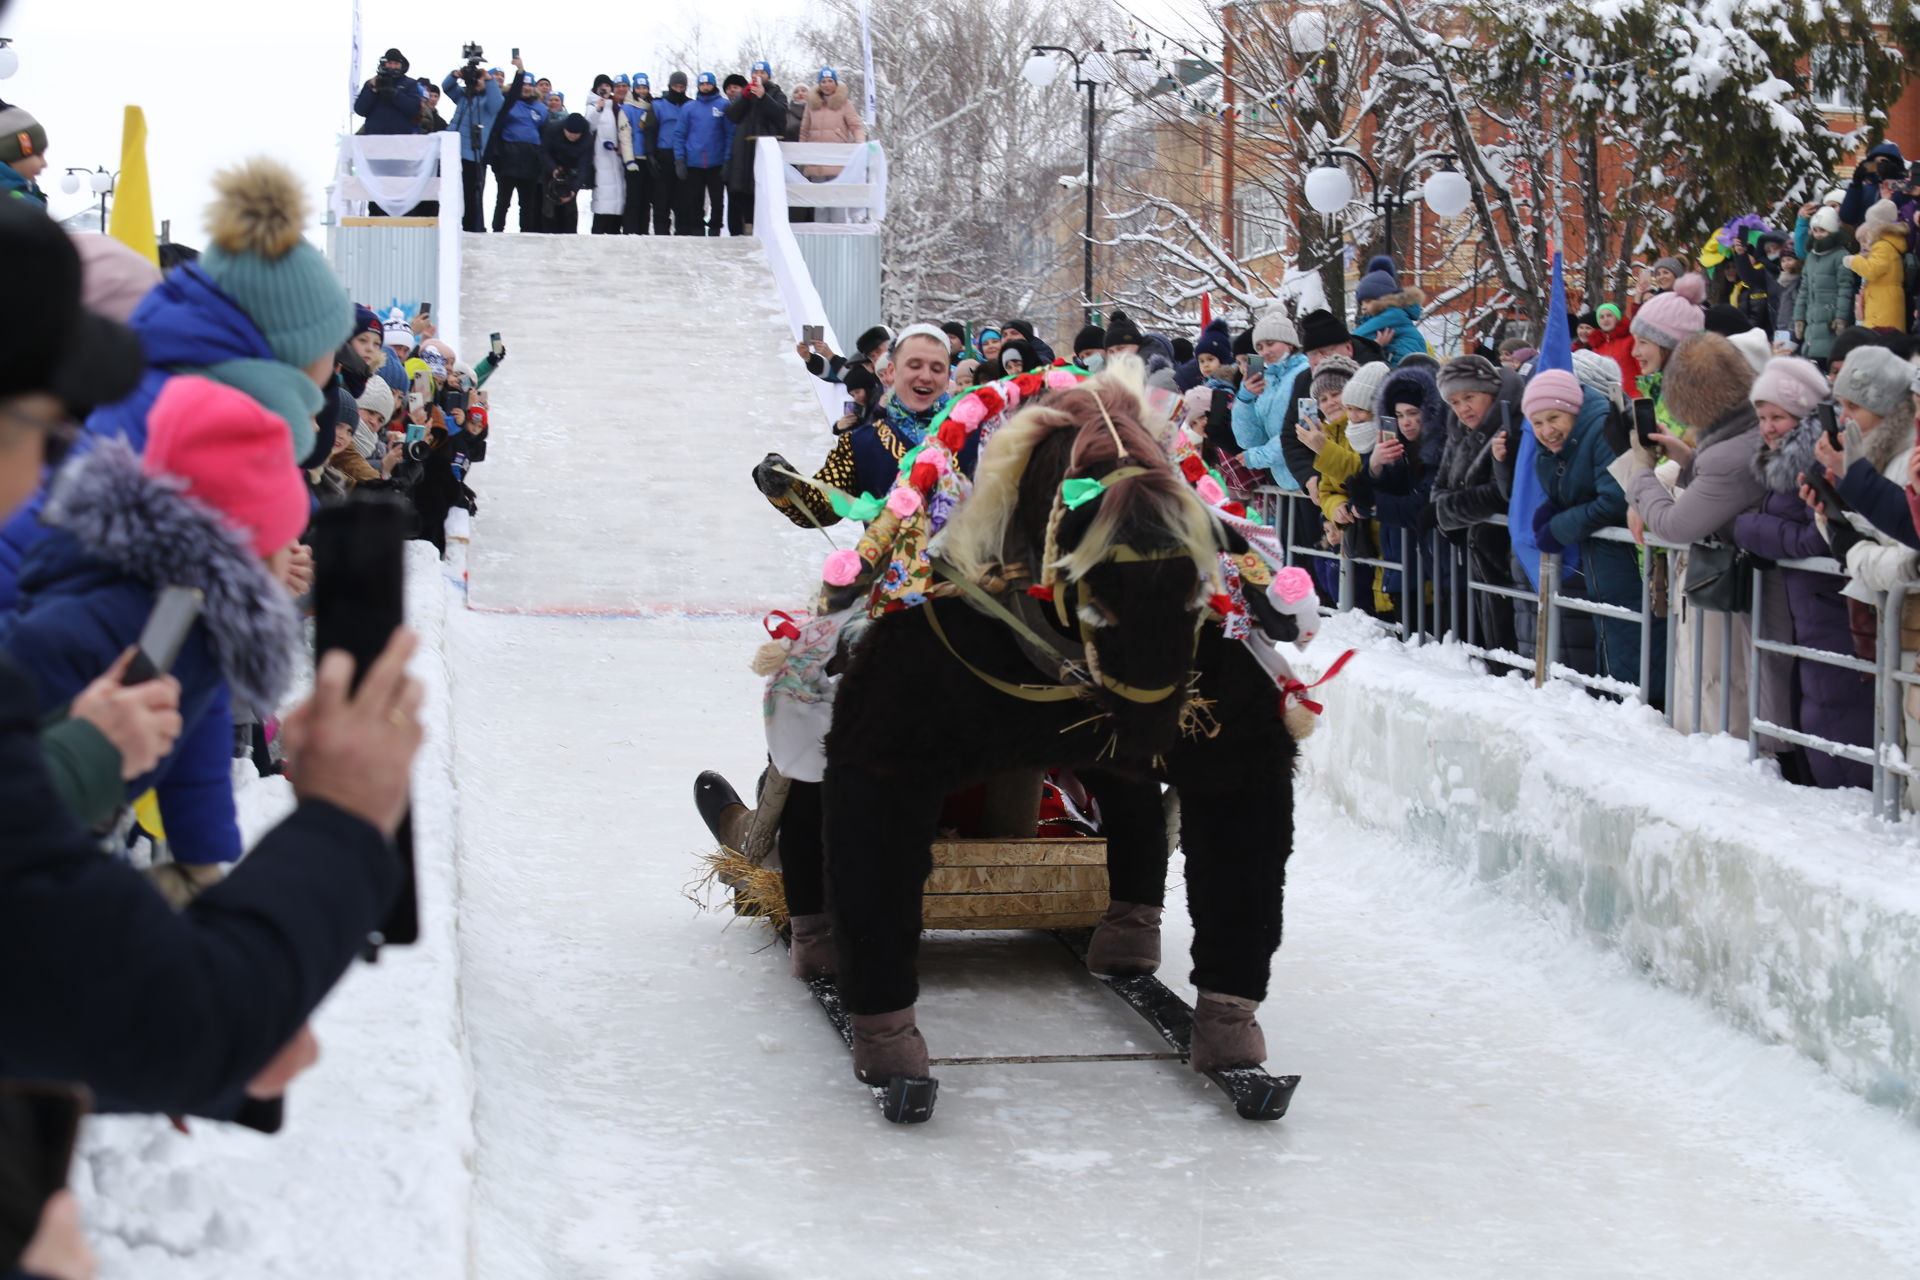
0,0,1200,246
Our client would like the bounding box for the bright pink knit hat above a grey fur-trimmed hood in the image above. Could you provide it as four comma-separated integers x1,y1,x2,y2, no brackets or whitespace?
140,374,307,557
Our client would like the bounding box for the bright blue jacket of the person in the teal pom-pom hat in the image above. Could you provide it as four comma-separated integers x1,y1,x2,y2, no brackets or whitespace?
0,263,284,610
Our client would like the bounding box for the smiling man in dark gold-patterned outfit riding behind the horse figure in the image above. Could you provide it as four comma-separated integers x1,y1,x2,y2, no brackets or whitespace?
753,333,960,528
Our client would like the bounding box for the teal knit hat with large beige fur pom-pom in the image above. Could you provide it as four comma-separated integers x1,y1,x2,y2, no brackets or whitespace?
200,157,353,368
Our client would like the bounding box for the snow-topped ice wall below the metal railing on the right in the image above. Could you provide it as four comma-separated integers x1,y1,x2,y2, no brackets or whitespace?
1306,618,1920,1121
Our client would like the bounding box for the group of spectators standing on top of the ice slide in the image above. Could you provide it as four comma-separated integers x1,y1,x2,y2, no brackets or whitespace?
353,46,866,236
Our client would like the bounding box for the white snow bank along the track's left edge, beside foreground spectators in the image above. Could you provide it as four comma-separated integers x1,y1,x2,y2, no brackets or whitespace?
73,543,472,1280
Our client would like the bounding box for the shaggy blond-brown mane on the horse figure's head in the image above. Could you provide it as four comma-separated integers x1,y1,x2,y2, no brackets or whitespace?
939,355,1219,581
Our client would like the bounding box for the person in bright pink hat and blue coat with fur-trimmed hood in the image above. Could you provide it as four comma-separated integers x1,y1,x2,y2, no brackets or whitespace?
0,376,307,890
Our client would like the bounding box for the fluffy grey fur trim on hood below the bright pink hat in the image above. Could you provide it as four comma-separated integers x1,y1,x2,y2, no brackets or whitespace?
42,439,300,706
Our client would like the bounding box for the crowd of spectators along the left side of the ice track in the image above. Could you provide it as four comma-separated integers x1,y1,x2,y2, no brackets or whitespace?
0,92,505,1278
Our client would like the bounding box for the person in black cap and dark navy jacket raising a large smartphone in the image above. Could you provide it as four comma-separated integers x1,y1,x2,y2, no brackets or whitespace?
0,197,420,1120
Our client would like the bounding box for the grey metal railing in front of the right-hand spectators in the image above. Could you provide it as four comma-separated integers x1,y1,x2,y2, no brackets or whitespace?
1254,486,1920,821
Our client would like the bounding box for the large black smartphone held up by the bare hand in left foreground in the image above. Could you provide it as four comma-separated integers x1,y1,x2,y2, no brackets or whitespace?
311,491,420,960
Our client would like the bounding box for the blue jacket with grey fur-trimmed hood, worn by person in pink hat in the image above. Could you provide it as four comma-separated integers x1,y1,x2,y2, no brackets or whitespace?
0,441,300,864
